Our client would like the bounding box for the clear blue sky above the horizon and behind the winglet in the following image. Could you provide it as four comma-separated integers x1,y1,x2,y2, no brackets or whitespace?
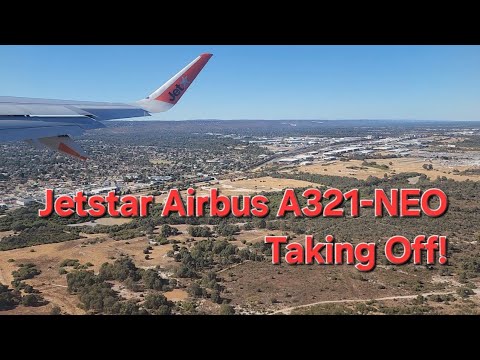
0,45,480,120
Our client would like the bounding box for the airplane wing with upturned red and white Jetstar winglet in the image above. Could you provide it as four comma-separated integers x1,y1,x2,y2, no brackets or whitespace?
0,54,212,160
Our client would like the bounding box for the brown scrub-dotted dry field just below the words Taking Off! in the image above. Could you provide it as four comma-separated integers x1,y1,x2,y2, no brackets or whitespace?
222,262,448,312
